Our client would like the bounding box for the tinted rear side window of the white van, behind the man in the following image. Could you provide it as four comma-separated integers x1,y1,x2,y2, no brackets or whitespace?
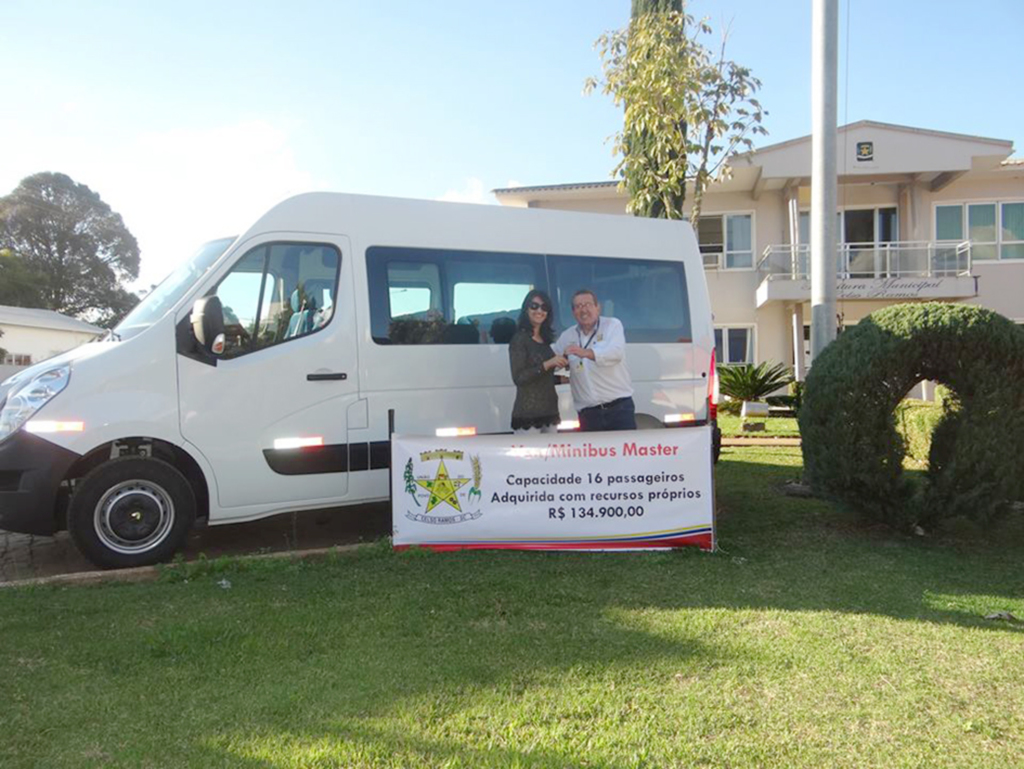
549,256,692,342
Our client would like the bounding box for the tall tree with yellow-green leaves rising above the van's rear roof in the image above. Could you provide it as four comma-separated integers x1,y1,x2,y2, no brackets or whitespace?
585,0,767,222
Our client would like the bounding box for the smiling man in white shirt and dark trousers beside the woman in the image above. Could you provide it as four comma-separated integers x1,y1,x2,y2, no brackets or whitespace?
551,289,637,432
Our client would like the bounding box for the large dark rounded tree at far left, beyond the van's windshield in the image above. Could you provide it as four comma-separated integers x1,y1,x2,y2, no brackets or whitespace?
0,173,139,322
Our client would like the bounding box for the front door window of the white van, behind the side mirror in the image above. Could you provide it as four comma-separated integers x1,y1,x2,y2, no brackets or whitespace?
213,243,341,357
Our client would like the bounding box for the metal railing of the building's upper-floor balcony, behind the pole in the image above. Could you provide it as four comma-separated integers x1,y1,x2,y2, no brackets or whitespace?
758,241,971,283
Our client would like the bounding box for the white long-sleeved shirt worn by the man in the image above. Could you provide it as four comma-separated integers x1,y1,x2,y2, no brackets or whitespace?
551,317,633,411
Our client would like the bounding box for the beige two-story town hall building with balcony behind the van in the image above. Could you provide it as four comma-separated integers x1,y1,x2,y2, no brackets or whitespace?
495,121,1024,385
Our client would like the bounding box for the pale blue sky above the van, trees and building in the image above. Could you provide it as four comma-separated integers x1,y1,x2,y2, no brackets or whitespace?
0,0,1024,285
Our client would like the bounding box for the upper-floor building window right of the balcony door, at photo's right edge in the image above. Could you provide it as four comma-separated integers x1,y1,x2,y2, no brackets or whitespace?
935,202,1024,260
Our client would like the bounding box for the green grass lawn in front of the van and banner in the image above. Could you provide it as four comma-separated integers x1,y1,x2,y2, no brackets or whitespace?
0,447,1024,768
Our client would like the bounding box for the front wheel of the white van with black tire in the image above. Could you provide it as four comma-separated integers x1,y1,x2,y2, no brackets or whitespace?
68,457,196,568
